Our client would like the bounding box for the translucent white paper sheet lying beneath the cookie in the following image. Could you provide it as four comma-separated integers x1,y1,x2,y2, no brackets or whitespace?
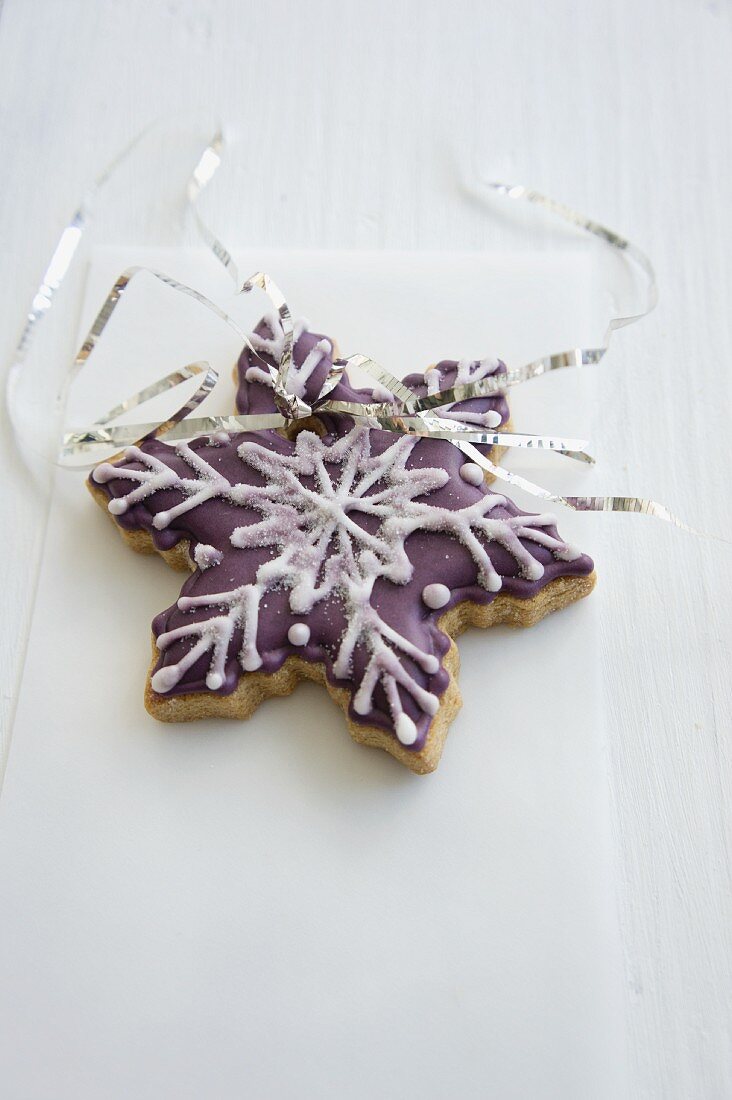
0,250,627,1100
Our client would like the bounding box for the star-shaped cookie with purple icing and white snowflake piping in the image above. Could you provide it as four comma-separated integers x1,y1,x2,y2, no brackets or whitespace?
89,329,594,772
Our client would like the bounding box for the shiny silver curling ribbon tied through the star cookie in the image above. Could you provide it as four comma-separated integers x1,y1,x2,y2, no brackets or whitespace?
9,128,701,534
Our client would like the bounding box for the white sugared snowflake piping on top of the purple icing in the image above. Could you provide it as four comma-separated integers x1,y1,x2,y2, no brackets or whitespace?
92,427,584,749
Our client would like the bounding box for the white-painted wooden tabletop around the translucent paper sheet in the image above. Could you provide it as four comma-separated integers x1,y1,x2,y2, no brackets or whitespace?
0,0,732,1100
